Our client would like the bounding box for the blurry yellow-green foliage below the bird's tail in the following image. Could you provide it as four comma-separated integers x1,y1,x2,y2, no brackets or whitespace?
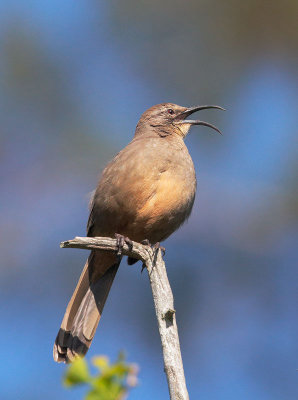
63,353,138,400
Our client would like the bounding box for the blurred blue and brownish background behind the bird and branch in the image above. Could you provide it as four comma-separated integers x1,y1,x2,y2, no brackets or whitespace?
0,0,298,400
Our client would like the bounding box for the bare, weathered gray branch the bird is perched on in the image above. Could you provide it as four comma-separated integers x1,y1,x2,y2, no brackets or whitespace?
60,237,189,400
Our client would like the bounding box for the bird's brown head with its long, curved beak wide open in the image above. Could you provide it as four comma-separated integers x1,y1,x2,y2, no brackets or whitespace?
135,103,224,138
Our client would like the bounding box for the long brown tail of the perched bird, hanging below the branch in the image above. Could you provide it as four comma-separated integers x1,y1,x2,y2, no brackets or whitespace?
53,251,120,363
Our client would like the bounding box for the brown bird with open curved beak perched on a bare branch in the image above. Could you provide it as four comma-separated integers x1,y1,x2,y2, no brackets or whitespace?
53,103,223,362
